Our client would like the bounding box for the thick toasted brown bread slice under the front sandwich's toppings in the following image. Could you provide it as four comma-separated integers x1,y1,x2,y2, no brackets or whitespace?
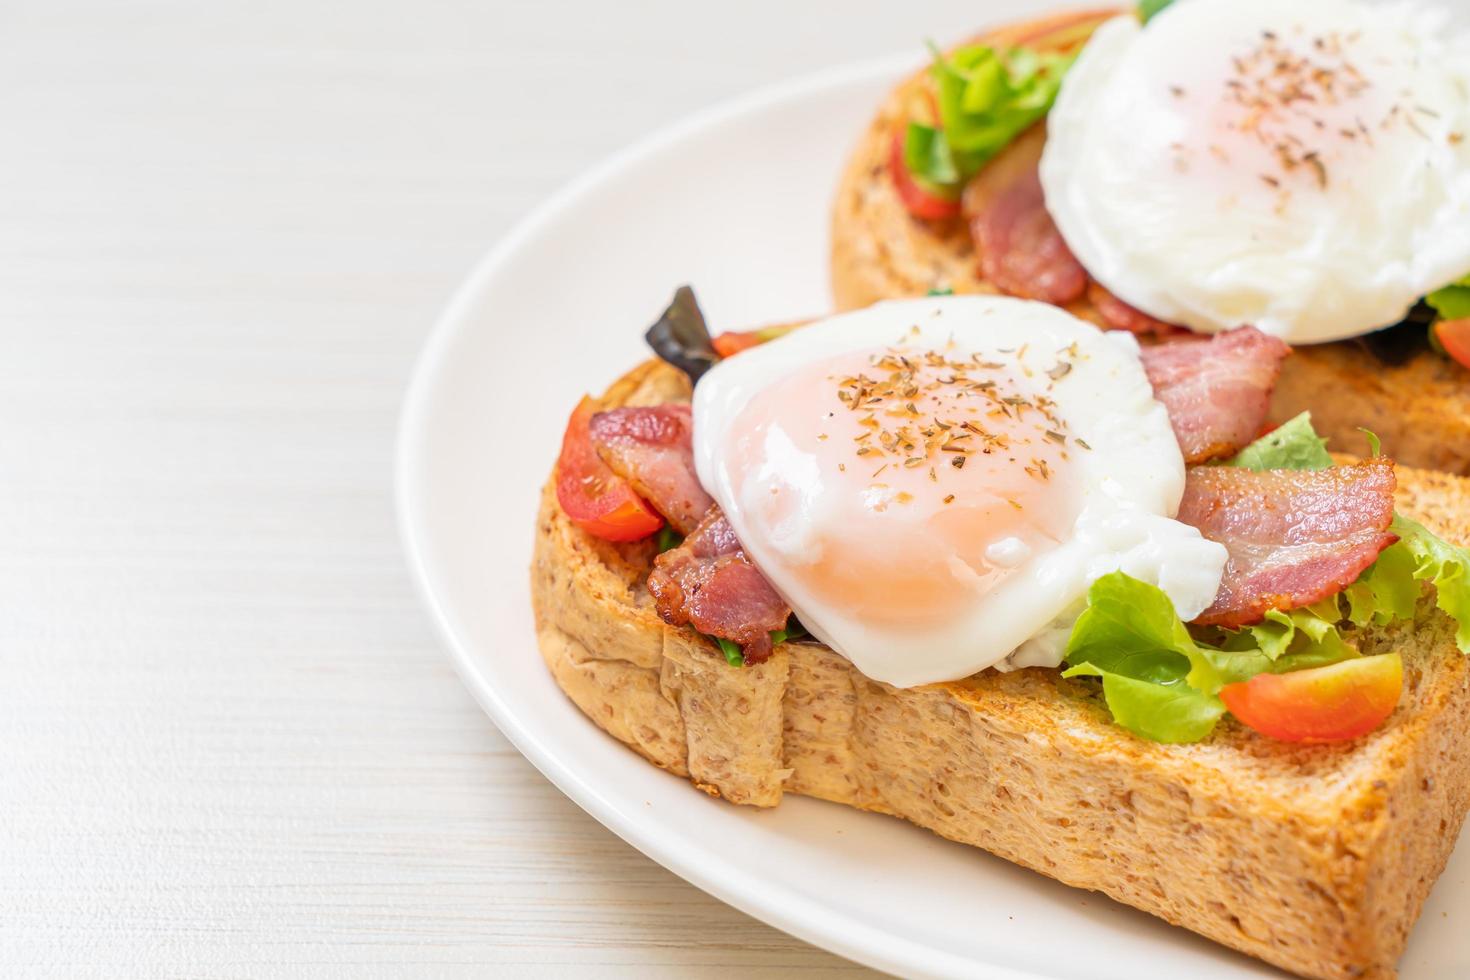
531,361,1470,980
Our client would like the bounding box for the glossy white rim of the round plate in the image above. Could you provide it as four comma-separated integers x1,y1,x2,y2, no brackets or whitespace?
392,54,1076,980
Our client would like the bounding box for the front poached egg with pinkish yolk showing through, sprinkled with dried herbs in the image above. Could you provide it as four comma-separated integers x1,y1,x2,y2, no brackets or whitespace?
694,297,1226,686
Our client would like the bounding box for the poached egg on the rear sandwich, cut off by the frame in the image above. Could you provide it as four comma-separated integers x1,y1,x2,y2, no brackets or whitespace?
1041,0,1470,344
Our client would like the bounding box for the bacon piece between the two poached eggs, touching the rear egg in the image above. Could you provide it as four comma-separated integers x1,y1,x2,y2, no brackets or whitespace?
1144,326,1291,463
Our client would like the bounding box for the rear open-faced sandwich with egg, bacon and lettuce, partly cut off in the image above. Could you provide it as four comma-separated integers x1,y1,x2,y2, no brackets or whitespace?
832,0,1470,473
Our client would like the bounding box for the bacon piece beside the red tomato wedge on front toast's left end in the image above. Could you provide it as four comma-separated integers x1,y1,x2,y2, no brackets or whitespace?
588,404,714,535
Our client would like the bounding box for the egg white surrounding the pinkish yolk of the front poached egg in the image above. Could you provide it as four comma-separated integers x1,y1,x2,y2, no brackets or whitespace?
694,297,1226,688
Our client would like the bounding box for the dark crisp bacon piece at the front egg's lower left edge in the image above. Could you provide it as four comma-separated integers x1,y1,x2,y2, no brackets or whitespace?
648,507,791,664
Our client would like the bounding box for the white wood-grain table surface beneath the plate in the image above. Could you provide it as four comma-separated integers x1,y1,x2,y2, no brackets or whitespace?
0,0,1040,977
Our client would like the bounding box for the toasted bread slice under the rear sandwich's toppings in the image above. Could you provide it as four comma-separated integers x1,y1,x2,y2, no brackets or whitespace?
831,15,1470,473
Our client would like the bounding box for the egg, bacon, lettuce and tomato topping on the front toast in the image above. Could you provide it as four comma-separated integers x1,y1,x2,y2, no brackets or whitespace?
557,290,1470,742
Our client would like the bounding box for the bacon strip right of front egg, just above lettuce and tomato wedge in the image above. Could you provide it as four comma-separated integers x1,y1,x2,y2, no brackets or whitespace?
1179,457,1398,627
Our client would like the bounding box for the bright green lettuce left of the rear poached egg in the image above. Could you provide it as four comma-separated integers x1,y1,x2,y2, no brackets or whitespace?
904,44,1075,194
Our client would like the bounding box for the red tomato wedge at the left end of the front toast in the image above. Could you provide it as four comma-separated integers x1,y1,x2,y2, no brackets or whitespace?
556,398,663,541
